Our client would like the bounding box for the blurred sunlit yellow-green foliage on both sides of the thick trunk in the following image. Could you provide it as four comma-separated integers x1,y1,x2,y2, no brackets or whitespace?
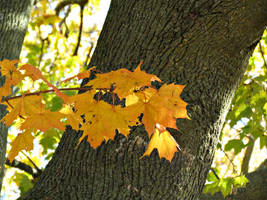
2,0,267,199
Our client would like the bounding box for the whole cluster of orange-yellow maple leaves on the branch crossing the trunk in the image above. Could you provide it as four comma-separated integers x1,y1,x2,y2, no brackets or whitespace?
0,60,188,162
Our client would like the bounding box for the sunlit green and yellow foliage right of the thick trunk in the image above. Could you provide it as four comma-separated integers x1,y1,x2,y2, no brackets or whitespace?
203,31,267,196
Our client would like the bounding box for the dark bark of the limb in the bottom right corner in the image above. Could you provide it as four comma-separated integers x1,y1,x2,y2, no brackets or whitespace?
200,167,267,200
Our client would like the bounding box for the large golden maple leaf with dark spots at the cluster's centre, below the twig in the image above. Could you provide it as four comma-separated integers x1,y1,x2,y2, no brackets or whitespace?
79,101,138,148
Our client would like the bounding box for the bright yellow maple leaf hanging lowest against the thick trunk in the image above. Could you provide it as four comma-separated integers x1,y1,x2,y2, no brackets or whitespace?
140,129,179,162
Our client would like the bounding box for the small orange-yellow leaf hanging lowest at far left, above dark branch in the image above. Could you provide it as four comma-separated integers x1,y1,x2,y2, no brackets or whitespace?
8,129,34,162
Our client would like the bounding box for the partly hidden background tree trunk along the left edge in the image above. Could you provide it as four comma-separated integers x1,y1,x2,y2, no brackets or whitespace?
0,0,33,191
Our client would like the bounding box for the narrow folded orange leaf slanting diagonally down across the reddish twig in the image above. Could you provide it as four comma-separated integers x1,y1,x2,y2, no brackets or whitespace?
20,64,68,102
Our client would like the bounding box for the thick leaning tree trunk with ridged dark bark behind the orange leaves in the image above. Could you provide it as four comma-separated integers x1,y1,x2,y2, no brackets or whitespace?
21,0,267,200
